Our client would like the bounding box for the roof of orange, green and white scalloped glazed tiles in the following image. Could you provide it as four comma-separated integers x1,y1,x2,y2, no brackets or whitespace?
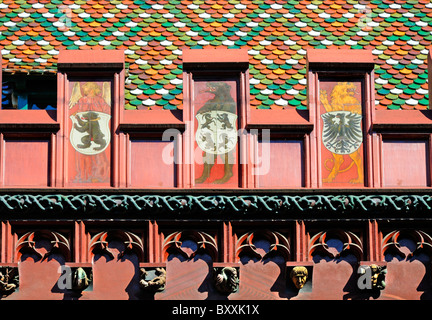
0,0,432,109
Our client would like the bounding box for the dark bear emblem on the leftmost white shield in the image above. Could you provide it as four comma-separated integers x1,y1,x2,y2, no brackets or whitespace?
74,111,106,151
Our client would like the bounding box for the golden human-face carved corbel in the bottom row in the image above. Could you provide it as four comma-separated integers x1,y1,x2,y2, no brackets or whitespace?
286,261,313,292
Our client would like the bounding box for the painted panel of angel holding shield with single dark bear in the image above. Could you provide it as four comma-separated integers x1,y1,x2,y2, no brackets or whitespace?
68,81,111,186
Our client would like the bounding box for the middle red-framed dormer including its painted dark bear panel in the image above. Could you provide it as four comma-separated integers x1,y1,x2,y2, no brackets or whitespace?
183,49,249,188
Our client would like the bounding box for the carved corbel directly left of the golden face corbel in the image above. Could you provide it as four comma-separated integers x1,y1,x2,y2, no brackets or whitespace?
213,262,240,295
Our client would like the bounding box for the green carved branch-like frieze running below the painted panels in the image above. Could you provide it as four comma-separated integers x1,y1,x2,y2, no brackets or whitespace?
0,194,432,216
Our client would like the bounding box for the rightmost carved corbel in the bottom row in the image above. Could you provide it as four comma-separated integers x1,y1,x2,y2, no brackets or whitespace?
357,261,387,292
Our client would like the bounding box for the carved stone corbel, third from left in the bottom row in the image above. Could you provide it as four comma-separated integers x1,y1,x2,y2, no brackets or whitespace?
139,263,166,293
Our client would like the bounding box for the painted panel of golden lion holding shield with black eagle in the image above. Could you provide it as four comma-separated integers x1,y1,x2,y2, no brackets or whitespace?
319,81,365,187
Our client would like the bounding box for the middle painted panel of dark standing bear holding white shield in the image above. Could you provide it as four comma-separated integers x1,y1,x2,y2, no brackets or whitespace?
195,81,238,186
